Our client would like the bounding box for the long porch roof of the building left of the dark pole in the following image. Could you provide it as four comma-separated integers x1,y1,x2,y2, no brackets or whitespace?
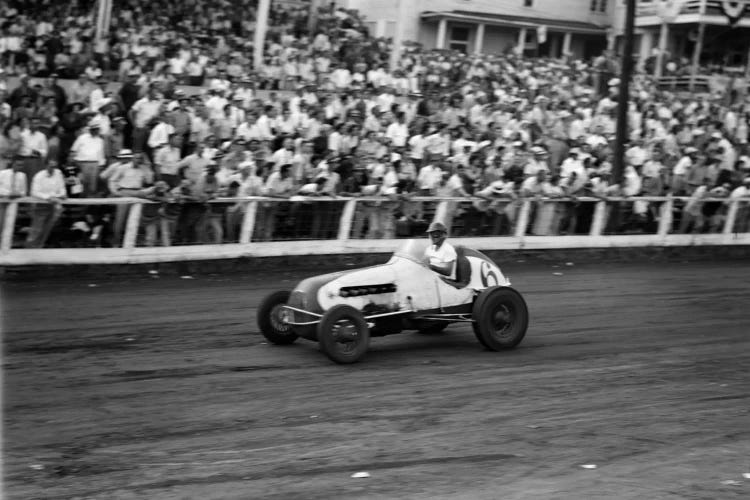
421,10,607,35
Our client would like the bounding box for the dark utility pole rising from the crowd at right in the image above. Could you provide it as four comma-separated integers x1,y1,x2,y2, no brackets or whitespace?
612,0,635,184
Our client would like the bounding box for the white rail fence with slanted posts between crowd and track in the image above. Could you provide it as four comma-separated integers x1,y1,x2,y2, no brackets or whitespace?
0,197,750,266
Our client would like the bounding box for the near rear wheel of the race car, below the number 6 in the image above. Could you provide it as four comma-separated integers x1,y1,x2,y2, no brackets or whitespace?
472,286,529,351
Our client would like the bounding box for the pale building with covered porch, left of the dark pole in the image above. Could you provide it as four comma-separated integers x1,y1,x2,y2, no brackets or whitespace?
336,0,622,59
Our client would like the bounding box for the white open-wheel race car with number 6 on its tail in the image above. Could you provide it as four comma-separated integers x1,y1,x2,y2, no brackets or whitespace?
257,240,529,363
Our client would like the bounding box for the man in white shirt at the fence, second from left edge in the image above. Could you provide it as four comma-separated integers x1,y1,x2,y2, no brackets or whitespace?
26,161,67,248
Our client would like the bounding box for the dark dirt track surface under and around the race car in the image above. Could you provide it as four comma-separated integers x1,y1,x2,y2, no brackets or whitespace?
2,262,750,500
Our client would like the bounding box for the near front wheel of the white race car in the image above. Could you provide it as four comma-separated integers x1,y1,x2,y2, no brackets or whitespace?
318,305,370,364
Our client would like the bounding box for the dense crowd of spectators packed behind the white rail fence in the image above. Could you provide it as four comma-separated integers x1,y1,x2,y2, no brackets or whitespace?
0,0,750,247
